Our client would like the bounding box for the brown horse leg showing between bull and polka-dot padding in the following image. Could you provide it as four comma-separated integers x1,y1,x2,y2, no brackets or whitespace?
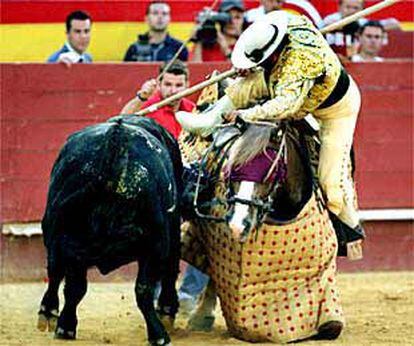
188,279,217,332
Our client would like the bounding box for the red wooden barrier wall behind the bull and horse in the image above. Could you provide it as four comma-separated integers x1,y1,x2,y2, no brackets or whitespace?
0,61,414,223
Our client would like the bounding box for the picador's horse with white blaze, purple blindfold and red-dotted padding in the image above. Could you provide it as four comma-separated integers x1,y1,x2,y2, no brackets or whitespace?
180,90,344,342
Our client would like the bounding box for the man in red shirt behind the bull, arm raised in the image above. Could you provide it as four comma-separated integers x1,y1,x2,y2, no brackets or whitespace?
121,60,195,139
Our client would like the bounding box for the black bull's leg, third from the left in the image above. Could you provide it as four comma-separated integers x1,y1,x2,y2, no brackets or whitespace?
135,257,171,346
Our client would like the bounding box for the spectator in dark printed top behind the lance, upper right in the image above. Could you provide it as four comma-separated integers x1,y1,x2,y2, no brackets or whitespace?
320,0,400,62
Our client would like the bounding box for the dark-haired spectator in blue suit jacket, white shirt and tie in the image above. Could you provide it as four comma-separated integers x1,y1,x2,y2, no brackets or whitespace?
47,11,92,66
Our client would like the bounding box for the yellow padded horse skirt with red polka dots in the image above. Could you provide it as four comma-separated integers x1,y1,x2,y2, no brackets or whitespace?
183,172,344,343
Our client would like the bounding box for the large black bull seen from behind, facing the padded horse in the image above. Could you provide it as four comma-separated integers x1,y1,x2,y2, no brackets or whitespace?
39,117,182,345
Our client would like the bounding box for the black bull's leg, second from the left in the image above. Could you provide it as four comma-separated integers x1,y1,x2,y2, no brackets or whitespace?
55,264,88,339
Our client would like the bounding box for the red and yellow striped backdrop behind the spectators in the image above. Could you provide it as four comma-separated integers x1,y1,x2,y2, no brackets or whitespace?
0,0,414,62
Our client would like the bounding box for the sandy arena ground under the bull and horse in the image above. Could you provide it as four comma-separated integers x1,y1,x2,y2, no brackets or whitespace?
0,272,414,346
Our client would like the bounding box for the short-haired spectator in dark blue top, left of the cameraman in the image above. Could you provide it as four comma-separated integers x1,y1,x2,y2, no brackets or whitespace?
124,1,188,61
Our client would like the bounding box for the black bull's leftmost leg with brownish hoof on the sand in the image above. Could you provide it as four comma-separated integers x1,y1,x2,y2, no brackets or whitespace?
37,250,65,332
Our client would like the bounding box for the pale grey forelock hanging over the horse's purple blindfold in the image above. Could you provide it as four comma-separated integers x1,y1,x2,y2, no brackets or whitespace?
227,125,273,169
